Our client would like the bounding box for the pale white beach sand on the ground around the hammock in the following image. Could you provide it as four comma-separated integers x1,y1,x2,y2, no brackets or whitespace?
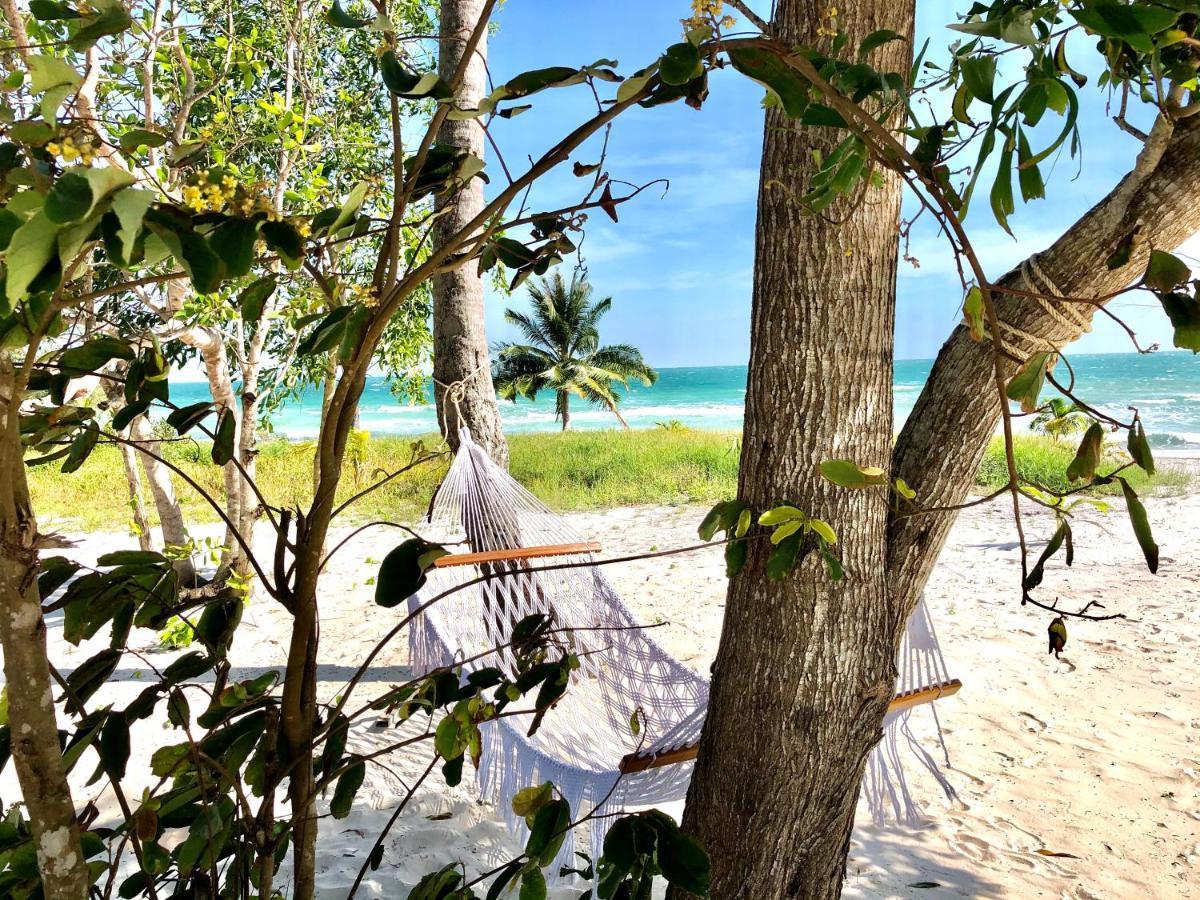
9,496,1200,898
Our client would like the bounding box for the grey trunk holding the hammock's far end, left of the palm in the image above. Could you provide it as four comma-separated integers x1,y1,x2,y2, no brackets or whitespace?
433,0,509,467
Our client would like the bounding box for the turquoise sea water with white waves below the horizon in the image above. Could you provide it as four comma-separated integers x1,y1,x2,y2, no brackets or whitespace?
172,352,1200,448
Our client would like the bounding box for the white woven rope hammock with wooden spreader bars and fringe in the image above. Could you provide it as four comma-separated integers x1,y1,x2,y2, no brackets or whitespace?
409,428,960,871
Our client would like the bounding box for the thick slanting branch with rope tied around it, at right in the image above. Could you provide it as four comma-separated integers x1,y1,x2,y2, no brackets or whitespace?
888,112,1200,613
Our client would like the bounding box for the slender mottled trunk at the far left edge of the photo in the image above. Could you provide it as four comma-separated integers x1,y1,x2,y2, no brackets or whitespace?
0,355,88,900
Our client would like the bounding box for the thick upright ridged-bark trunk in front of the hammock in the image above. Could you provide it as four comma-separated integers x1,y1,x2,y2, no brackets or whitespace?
684,0,913,900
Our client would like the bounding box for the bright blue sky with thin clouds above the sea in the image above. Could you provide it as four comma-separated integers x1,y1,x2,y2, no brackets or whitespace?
477,0,1190,367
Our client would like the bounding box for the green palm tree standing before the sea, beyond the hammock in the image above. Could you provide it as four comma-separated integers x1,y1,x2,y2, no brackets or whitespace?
492,274,659,431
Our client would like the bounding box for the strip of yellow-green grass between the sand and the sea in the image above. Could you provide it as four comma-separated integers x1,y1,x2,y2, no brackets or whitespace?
29,428,1190,530
